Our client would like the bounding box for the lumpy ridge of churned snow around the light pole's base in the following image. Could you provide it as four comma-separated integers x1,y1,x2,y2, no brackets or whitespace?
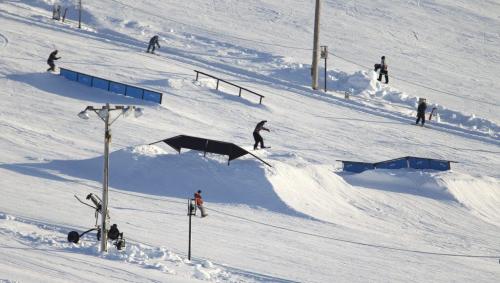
0,213,237,282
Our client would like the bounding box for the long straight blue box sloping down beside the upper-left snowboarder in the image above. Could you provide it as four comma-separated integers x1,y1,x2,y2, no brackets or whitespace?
59,68,163,104
